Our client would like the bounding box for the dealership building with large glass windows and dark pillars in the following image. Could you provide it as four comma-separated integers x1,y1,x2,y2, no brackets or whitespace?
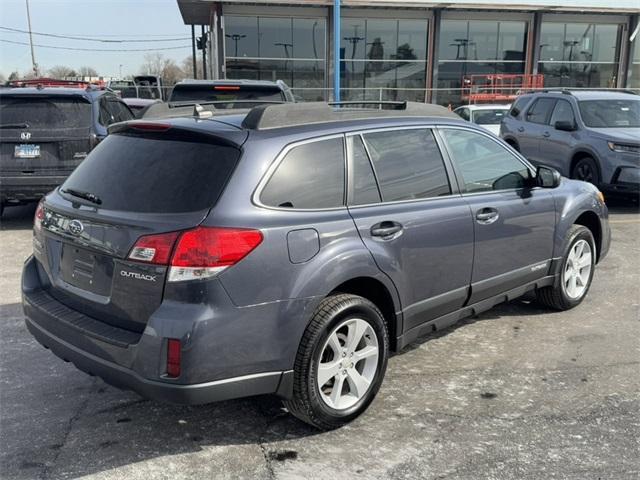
177,0,640,105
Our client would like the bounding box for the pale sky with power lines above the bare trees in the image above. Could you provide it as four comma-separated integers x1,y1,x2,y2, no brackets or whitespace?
0,0,191,77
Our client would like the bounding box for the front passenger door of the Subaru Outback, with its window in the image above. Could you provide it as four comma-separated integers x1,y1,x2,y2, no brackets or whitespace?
439,127,556,303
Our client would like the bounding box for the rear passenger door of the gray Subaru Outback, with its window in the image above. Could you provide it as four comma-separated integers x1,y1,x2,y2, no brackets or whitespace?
347,127,473,331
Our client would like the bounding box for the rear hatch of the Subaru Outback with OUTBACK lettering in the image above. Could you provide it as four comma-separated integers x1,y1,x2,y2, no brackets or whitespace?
35,125,245,332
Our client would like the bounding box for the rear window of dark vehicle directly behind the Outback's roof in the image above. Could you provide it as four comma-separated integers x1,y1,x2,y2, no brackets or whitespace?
170,85,285,108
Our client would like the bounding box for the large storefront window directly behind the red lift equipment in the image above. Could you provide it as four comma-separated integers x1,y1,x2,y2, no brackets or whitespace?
434,20,527,107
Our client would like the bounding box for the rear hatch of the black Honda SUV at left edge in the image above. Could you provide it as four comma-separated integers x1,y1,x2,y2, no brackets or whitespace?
0,94,92,176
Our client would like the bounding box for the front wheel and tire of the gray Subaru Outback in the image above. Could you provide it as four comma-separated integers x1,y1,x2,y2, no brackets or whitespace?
536,225,596,310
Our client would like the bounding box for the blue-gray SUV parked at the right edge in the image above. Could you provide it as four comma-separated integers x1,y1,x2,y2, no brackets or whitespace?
500,90,640,196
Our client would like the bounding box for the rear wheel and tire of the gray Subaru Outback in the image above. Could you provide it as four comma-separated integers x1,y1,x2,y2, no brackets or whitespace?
285,294,389,430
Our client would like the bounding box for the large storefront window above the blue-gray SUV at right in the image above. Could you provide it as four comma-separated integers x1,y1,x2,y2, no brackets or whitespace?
538,22,621,88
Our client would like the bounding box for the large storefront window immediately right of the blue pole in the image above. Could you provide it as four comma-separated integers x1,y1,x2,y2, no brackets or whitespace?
340,17,427,102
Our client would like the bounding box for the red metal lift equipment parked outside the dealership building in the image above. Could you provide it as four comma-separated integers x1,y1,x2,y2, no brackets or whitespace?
462,74,544,103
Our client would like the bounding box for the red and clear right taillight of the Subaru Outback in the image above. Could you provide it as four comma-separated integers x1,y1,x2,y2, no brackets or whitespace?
129,227,263,282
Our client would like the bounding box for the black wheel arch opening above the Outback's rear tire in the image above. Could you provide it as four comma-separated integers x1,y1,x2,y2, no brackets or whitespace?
330,277,401,351
